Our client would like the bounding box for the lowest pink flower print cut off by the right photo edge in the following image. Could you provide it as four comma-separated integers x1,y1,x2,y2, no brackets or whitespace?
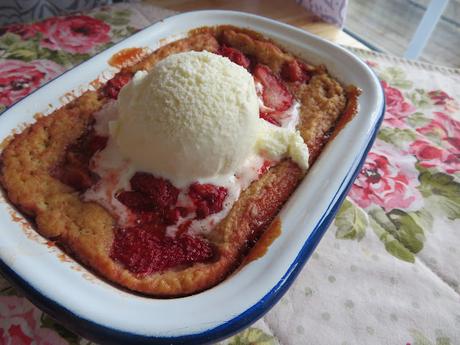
410,139,460,174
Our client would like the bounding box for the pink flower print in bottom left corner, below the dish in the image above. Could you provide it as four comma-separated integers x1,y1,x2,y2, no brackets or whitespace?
0,296,67,345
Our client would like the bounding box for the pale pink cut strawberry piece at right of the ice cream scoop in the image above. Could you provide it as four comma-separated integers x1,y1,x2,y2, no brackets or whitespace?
253,64,294,111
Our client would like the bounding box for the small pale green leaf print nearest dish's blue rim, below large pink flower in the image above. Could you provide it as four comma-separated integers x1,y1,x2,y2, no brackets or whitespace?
334,199,369,241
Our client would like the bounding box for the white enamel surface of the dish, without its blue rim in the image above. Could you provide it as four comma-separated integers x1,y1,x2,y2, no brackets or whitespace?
0,11,383,336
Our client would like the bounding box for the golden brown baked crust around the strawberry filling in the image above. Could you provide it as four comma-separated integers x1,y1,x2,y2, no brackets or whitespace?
0,26,356,297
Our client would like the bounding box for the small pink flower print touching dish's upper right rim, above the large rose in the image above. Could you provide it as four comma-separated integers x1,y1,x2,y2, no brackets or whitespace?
382,81,415,128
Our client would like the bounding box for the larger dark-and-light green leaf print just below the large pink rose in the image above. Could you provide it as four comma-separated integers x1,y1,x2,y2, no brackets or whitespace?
369,207,433,262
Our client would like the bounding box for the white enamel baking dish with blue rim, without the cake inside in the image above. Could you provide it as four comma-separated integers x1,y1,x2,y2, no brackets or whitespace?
0,11,384,344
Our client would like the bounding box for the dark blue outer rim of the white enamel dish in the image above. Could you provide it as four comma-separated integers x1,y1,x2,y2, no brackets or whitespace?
0,10,386,345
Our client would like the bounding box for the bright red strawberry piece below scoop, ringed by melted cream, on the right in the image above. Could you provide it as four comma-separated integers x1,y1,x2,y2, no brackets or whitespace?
188,183,228,219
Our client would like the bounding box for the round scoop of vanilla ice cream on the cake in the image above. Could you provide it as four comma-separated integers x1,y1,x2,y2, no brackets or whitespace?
111,52,260,186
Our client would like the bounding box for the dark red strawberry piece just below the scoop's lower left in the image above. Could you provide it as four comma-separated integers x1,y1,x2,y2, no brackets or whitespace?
130,172,179,209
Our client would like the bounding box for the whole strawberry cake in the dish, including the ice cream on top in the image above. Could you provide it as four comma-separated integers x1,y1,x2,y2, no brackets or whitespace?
0,26,359,297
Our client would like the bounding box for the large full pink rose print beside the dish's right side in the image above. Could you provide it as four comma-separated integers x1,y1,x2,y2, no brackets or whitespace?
349,140,422,212
